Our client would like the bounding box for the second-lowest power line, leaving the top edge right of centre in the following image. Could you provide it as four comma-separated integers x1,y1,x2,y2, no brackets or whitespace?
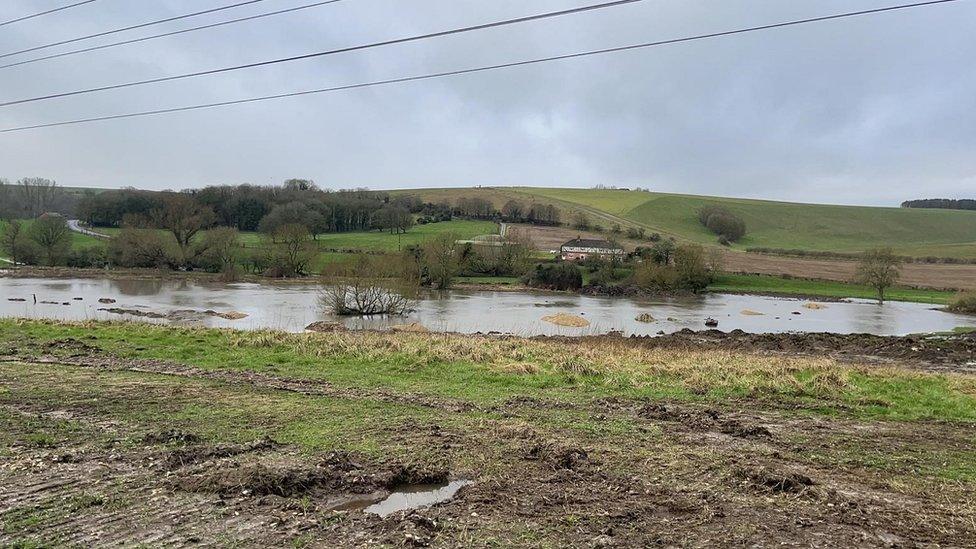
0,0,644,107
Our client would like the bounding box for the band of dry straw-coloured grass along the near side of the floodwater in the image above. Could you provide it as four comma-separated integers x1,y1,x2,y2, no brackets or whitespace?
225,332,928,396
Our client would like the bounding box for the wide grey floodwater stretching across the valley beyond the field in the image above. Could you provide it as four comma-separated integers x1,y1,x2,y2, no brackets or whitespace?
0,278,976,336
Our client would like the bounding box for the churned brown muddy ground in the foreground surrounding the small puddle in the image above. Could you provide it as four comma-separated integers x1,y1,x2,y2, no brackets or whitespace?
0,334,976,547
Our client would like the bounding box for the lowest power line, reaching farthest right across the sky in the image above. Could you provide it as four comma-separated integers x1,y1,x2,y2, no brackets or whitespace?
0,0,958,133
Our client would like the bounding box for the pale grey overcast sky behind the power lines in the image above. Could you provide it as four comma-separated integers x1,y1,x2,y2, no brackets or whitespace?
0,0,976,205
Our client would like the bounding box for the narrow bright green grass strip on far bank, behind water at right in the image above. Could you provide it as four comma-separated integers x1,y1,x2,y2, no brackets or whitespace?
708,274,955,305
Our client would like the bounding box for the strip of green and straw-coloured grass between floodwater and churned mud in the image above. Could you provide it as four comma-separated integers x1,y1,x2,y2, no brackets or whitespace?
0,320,976,420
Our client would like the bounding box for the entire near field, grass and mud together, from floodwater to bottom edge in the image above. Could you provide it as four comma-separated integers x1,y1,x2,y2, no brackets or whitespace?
0,320,976,548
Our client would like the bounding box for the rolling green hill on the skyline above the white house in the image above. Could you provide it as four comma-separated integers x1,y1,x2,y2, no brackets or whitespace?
407,187,976,258
